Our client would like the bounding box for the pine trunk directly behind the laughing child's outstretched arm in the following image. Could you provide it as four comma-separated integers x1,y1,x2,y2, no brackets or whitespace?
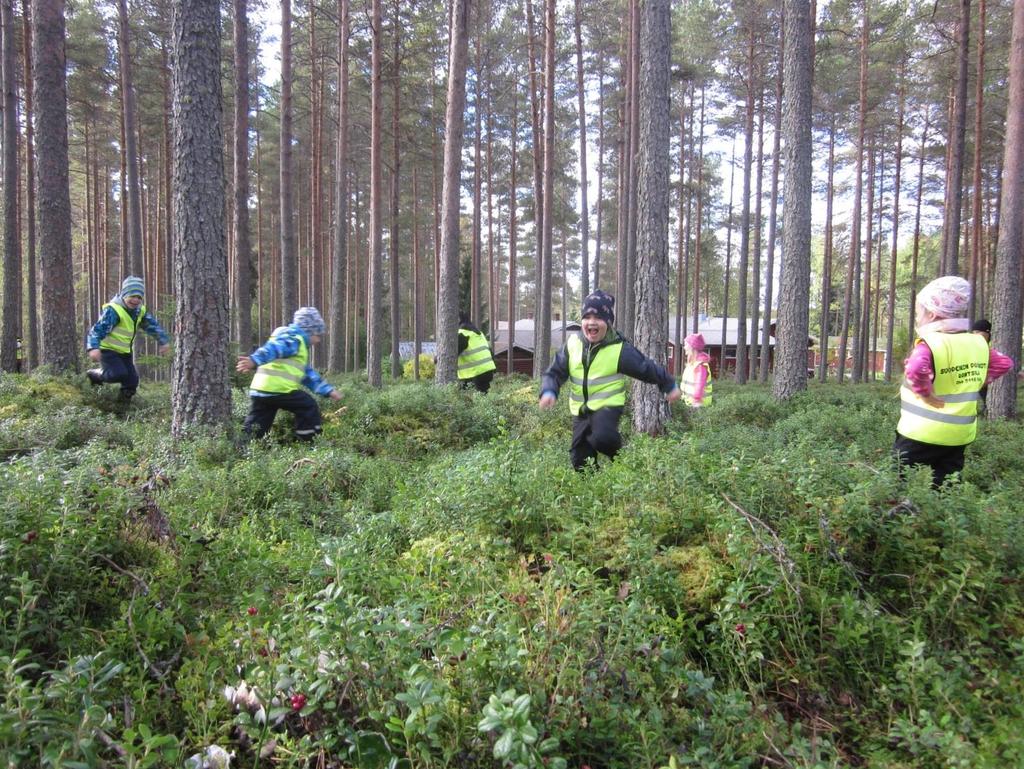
633,0,672,435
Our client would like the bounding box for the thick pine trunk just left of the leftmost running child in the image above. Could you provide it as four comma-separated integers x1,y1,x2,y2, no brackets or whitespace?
32,0,79,372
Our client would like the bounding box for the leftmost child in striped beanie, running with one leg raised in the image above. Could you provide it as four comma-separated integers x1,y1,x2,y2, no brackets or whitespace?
85,275,170,400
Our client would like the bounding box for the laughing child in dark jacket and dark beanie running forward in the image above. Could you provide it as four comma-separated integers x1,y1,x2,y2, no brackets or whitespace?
539,291,682,470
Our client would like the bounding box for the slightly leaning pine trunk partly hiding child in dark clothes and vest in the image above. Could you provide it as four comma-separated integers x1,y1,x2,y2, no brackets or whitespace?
434,0,472,385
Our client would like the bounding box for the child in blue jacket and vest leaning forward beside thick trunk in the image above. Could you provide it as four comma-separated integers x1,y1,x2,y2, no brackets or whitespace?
234,307,341,441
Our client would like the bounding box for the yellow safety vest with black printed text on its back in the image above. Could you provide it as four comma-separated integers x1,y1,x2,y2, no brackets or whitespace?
896,333,988,445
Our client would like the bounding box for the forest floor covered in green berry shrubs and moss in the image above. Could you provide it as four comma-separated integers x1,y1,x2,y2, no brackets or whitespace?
0,376,1024,769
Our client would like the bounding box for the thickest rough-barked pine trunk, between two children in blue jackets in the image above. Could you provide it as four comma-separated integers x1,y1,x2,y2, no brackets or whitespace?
171,0,231,437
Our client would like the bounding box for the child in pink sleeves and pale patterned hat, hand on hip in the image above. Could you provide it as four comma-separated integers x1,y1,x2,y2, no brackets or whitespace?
893,275,1013,488
